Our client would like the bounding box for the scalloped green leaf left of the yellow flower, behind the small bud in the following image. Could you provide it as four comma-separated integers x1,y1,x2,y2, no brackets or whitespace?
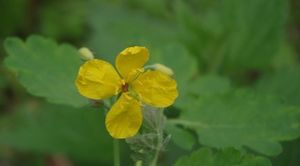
5,36,87,107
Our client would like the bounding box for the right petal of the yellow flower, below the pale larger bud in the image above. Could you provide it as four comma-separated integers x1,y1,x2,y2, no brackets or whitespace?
131,71,178,107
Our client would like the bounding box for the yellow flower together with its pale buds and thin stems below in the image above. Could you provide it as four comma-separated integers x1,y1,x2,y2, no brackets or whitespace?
75,46,178,165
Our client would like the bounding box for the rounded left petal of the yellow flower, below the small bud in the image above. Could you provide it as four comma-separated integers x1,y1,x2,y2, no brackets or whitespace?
76,59,121,99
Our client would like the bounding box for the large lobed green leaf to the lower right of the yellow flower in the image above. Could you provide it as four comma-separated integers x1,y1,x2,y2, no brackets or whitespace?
169,76,300,155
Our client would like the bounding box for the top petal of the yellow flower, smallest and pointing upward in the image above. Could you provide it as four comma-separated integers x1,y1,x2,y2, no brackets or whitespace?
116,46,149,82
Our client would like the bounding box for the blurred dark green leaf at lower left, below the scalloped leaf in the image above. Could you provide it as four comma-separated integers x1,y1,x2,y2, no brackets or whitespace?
0,101,112,162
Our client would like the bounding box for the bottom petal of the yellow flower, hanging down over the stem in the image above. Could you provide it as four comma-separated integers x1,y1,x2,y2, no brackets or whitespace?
105,93,143,139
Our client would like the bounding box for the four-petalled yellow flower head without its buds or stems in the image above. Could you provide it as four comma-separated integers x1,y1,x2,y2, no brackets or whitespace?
76,46,178,139
